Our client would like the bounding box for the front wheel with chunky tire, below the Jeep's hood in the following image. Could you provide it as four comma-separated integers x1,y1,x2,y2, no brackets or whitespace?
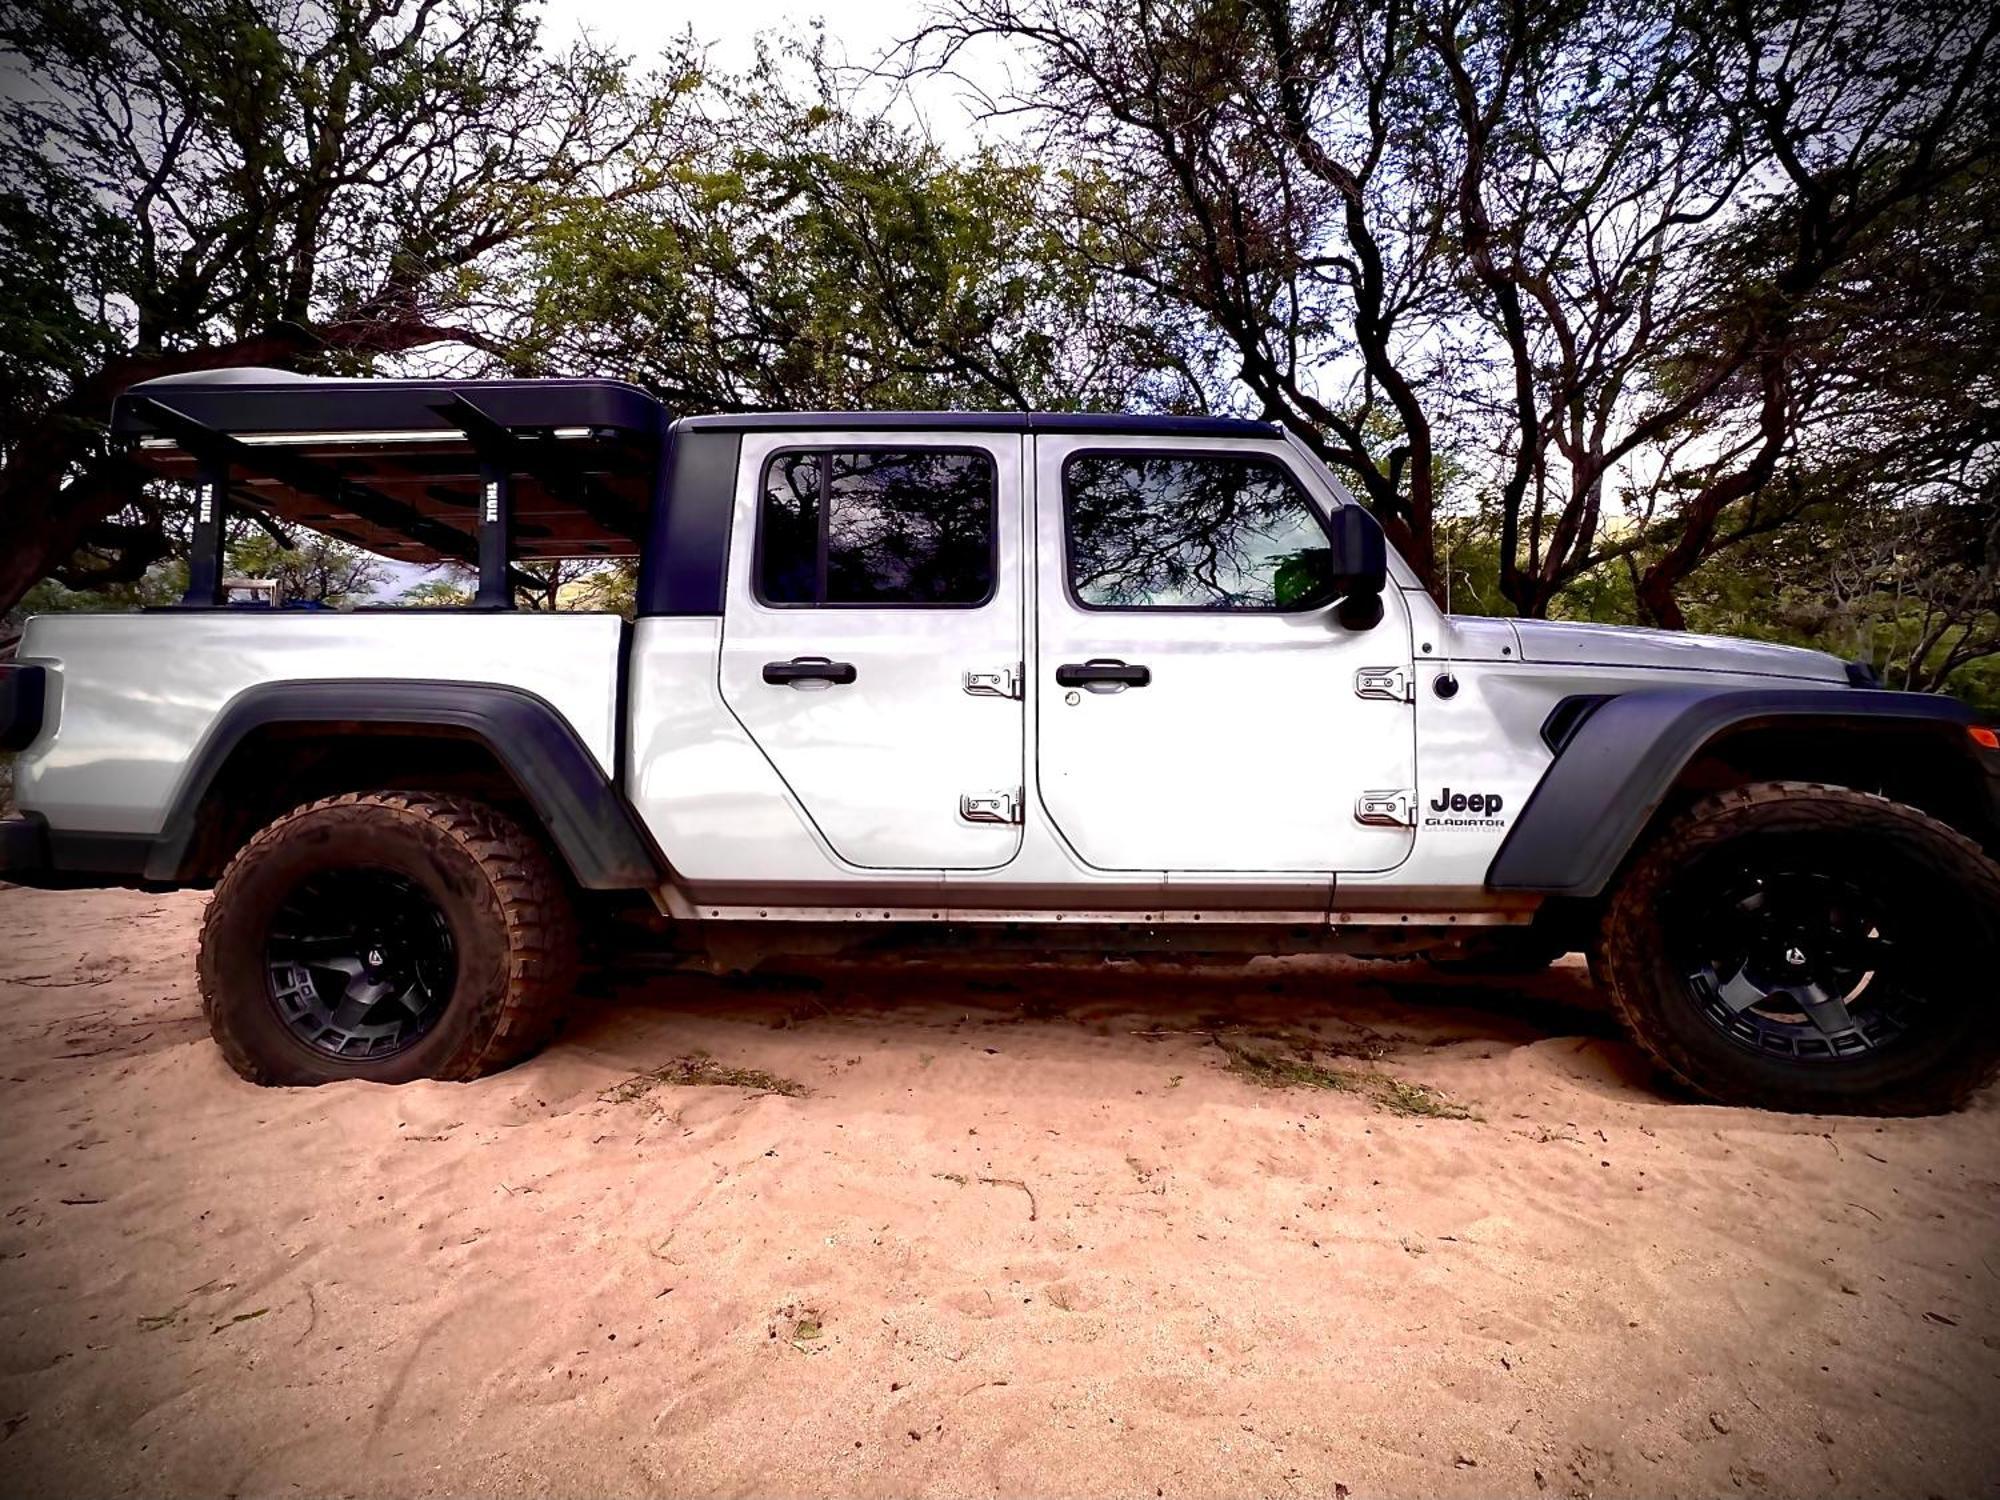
1594,782,2000,1114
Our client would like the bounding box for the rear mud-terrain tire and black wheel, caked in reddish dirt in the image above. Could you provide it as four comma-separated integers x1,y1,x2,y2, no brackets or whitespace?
196,792,576,1084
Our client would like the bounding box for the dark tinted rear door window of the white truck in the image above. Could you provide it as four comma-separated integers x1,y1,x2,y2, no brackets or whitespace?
756,448,994,608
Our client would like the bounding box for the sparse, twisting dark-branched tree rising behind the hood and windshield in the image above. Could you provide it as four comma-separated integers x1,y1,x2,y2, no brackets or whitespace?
912,0,1996,624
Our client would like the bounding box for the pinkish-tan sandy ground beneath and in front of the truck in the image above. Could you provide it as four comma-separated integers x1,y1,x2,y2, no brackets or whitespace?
0,890,2000,1500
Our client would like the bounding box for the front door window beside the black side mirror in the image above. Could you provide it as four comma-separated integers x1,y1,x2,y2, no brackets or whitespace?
1062,454,1334,610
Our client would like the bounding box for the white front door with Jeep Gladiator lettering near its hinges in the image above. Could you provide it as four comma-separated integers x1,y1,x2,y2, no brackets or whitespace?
1034,436,1416,872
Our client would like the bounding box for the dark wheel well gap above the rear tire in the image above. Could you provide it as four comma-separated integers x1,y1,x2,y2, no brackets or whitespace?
180,722,540,884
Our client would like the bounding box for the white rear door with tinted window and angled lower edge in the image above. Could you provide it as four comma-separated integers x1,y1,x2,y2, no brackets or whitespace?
720,430,1024,870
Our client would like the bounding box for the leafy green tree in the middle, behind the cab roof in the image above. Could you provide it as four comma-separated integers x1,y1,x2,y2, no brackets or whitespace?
518,50,1204,410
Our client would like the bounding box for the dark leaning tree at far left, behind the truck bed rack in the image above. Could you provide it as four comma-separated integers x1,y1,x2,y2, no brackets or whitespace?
0,0,676,608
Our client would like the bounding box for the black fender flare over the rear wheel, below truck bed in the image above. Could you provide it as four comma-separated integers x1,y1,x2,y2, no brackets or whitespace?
146,678,666,890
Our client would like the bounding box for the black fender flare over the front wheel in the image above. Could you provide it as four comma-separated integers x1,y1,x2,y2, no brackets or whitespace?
1486,686,1976,898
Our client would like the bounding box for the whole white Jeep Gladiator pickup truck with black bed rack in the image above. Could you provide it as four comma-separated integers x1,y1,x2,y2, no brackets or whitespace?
0,372,2000,1112
